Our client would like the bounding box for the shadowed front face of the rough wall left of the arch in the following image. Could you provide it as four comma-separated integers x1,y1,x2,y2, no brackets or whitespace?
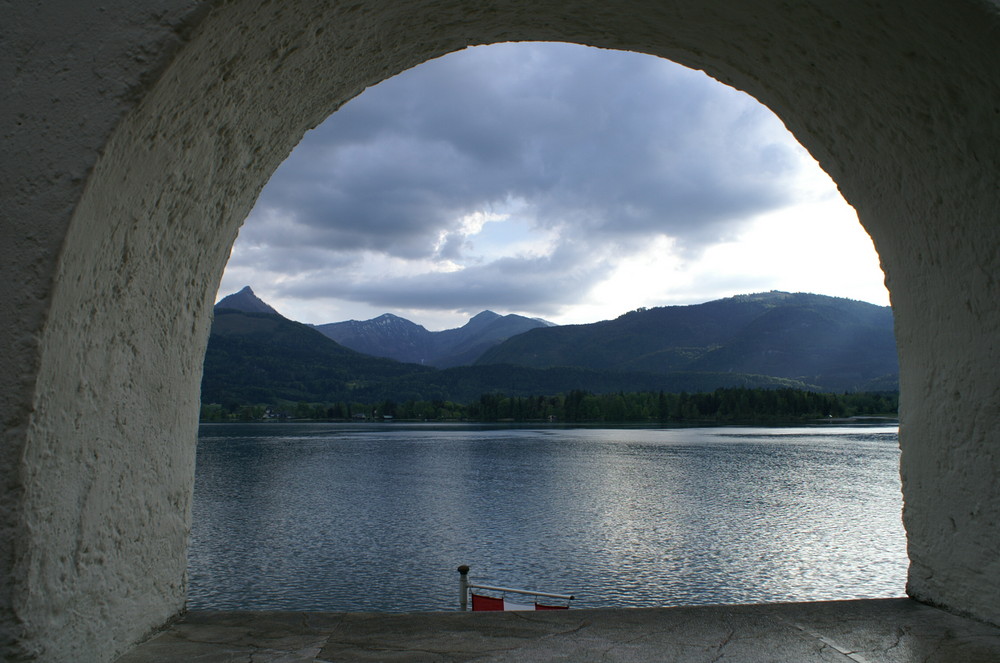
0,0,213,661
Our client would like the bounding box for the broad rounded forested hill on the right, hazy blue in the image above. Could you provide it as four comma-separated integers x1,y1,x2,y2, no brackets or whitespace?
476,292,899,391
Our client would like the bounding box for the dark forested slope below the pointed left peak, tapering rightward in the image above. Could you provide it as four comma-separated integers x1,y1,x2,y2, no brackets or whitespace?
202,309,814,405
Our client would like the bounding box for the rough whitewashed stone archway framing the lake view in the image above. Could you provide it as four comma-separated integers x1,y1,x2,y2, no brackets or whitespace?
0,0,1000,661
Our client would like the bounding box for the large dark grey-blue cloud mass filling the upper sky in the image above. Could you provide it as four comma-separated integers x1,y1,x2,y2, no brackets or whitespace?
236,44,799,310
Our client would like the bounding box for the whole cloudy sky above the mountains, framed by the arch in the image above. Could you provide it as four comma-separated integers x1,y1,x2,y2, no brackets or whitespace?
219,43,889,330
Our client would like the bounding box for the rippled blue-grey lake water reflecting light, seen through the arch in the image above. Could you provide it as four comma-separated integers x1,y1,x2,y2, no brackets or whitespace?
188,424,907,612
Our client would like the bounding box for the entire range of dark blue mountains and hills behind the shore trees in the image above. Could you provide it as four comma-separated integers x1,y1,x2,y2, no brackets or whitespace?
202,287,898,404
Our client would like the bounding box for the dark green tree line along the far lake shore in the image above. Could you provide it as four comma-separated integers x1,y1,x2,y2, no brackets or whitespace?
201,387,899,424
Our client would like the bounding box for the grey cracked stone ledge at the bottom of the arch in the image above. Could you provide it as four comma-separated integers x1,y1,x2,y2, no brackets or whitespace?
113,599,1000,663
